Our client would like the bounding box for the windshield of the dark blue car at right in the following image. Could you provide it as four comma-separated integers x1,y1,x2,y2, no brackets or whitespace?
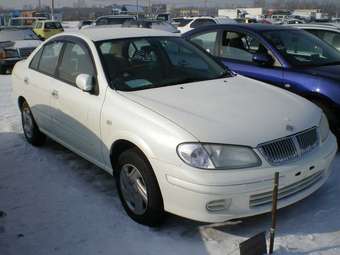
263,30,340,67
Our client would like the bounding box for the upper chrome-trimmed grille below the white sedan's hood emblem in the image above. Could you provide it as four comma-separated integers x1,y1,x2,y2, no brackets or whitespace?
258,128,319,165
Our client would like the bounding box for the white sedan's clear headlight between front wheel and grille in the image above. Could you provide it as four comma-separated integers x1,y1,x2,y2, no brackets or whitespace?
177,143,261,169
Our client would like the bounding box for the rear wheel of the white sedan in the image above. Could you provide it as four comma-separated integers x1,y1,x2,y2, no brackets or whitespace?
20,102,46,146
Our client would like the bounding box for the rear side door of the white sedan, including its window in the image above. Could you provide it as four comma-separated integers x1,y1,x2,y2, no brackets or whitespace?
24,41,63,133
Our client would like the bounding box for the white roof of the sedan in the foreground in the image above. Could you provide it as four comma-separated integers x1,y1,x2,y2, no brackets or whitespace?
66,27,179,42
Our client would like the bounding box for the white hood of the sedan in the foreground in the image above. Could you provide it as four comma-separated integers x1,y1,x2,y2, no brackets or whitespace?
119,75,321,147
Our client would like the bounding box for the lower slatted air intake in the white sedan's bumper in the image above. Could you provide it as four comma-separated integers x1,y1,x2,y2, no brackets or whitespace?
249,171,324,208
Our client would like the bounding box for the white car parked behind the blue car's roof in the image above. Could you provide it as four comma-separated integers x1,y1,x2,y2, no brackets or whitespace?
172,16,237,33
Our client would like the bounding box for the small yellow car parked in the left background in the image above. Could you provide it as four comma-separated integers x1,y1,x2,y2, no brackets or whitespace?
33,20,64,40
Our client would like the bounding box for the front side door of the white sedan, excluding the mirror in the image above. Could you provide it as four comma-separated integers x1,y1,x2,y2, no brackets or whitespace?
52,39,104,164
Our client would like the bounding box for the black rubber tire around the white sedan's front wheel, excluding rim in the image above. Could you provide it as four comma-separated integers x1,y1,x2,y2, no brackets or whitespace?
116,148,165,227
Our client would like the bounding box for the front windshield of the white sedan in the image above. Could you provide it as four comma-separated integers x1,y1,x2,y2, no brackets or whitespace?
97,37,231,91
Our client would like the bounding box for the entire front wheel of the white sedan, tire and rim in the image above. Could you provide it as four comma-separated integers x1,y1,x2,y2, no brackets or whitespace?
116,148,165,227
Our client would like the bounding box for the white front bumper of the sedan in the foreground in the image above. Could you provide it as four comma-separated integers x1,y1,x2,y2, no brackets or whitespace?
150,134,337,222
